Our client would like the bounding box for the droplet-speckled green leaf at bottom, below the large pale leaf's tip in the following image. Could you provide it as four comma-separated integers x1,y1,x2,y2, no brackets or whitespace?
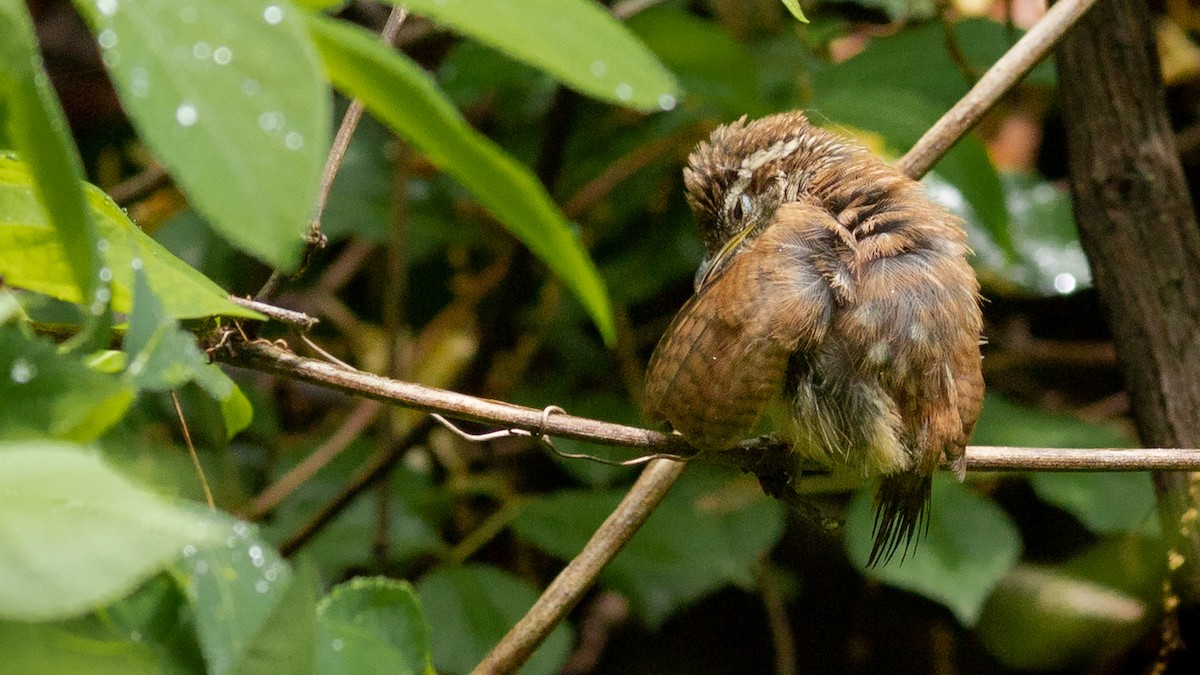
175,514,300,675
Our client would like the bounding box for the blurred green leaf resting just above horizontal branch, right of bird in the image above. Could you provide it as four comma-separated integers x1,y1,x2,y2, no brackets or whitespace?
971,394,1136,448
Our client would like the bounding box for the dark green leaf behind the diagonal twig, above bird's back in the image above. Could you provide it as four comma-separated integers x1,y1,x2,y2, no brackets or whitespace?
814,83,1016,252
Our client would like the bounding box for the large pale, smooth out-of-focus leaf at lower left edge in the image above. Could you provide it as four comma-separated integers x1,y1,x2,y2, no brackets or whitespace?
0,441,218,621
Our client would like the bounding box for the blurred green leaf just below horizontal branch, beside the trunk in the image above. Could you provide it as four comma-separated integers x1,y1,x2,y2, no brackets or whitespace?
1030,472,1158,534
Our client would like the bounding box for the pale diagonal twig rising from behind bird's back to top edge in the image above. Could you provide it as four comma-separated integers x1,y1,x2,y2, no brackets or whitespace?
896,0,1096,178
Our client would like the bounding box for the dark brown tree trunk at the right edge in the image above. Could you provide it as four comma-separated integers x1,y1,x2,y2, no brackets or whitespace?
1057,0,1200,658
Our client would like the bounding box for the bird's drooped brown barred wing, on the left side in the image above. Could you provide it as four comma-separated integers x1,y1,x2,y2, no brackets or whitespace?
646,204,851,449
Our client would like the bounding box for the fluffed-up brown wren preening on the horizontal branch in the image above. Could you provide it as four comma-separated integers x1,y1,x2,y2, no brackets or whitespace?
646,113,983,565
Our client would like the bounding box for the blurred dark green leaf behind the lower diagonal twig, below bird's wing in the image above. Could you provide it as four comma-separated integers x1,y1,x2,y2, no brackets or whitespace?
513,467,784,627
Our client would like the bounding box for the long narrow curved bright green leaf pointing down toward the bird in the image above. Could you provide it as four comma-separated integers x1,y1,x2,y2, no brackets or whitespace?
308,14,616,345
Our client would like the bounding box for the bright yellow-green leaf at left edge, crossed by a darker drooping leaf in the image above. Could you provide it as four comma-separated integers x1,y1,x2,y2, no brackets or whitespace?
0,156,263,318
